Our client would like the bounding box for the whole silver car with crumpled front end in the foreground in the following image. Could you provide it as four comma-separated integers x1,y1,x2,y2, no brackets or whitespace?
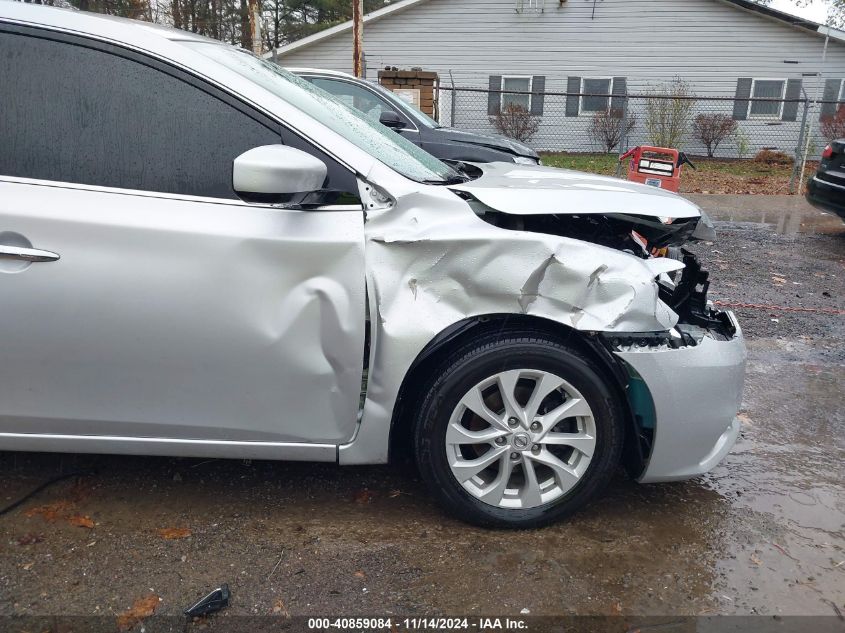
0,2,745,527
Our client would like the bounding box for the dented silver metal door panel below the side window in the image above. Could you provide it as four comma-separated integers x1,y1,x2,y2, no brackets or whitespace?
0,180,364,443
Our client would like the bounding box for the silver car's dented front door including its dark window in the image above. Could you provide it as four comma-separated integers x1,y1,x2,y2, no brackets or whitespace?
0,25,365,446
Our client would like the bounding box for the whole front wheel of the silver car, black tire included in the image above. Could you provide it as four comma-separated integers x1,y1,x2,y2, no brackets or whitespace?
414,333,624,528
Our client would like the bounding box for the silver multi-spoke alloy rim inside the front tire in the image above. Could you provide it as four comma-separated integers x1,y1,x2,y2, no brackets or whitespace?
445,369,596,508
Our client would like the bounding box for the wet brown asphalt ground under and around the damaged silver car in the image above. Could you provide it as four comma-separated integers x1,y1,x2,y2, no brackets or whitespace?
0,196,845,630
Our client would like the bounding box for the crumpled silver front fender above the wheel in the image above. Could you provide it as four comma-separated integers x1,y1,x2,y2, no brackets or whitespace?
340,167,683,463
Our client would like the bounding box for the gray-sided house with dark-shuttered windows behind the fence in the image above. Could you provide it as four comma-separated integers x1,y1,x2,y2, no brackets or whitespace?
268,0,845,156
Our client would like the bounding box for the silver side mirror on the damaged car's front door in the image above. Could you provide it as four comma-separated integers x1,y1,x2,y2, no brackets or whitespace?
232,145,328,201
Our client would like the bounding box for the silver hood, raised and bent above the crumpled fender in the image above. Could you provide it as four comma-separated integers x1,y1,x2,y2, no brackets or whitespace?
450,163,701,220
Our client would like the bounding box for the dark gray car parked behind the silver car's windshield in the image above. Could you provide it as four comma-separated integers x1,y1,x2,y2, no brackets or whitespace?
288,68,540,165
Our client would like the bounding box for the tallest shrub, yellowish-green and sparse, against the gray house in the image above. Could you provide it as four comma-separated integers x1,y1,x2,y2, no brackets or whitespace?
645,77,695,147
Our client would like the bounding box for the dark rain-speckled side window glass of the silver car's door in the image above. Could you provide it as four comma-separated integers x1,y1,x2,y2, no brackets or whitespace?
0,32,280,198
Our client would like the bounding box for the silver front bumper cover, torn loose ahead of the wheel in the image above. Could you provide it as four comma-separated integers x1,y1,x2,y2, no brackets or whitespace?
614,313,746,483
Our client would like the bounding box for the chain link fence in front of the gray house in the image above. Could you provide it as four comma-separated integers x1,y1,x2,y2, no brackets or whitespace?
438,83,845,193
